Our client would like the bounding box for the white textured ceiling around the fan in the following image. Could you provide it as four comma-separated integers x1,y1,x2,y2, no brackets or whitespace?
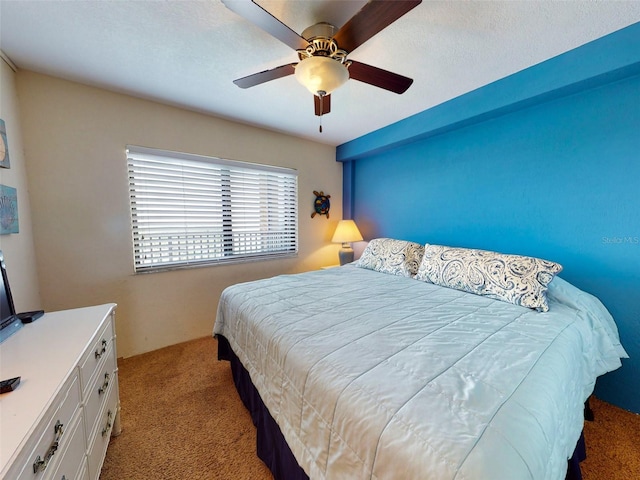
0,0,640,145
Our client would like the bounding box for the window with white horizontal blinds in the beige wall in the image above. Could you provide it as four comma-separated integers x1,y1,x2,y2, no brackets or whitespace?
127,146,298,272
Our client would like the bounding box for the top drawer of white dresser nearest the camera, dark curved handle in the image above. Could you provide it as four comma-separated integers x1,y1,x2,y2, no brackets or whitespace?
7,373,84,480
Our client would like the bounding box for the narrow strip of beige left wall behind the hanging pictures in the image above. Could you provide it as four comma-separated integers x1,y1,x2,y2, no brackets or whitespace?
0,59,42,312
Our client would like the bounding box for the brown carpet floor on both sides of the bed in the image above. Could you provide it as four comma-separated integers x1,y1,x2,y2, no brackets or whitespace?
100,338,640,480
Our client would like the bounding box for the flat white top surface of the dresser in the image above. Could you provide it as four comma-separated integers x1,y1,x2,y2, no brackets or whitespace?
0,303,116,472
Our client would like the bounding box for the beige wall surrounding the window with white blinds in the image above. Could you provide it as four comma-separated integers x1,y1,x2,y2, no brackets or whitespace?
17,71,342,356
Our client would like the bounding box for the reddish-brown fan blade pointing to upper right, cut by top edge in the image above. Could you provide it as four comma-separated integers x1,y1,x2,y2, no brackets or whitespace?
333,0,422,53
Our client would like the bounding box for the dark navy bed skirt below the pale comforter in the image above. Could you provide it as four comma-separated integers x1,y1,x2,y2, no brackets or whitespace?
216,335,590,480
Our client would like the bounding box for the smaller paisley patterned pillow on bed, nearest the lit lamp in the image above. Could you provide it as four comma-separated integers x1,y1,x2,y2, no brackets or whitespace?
357,238,424,277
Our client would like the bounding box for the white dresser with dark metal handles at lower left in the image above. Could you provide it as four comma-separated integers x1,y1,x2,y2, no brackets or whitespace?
0,303,120,480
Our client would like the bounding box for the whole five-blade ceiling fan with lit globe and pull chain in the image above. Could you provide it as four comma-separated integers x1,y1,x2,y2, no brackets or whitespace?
222,0,422,127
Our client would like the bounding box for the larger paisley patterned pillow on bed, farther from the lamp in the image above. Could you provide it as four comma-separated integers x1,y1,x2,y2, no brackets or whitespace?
416,245,562,312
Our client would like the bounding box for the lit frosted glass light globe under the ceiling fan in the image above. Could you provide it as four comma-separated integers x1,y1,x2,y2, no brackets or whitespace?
295,57,349,95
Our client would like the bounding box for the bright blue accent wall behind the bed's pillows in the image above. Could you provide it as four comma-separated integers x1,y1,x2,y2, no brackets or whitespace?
337,24,640,412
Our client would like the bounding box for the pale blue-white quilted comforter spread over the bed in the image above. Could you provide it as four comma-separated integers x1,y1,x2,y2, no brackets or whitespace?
214,265,626,480
